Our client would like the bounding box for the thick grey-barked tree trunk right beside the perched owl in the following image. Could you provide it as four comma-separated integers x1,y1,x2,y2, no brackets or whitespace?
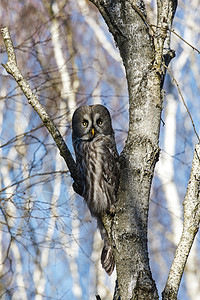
88,0,177,300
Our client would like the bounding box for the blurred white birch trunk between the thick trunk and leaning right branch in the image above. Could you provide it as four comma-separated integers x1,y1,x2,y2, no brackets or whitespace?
157,94,182,246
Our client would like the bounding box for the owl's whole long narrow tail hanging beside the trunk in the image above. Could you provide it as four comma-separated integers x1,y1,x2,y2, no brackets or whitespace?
96,216,115,275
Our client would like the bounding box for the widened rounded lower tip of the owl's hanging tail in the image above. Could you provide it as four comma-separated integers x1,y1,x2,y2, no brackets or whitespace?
101,245,115,275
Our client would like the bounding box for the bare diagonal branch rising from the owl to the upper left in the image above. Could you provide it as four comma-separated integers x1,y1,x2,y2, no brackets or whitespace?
1,27,79,186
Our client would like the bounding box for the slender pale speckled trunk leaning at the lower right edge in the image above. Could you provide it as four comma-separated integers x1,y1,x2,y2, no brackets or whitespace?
162,144,200,300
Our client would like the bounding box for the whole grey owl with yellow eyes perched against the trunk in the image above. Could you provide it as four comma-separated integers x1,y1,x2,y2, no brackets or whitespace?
72,104,120,275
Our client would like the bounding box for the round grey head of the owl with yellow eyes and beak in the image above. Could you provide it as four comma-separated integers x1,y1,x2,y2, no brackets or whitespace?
72,104,113,141
